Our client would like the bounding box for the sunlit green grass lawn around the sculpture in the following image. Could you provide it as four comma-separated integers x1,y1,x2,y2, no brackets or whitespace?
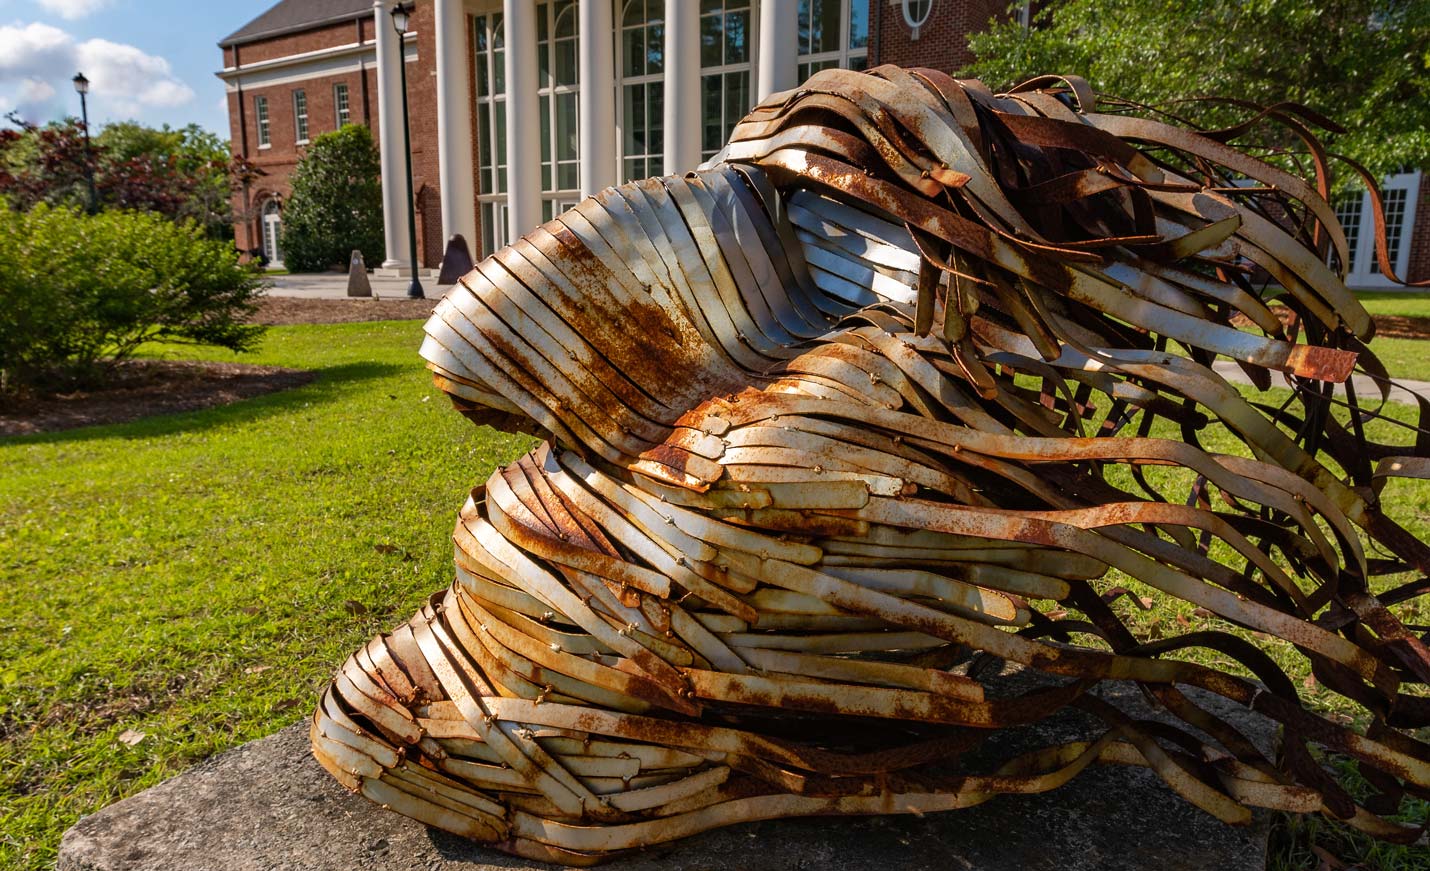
0,322,1430,871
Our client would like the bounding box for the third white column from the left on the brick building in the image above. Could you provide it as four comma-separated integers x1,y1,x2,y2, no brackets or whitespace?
502,0,543,239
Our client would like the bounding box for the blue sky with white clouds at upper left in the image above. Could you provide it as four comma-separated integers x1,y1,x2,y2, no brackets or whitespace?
0,0,276,137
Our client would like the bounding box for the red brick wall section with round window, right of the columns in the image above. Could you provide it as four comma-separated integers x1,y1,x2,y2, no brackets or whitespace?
869,0,1008,73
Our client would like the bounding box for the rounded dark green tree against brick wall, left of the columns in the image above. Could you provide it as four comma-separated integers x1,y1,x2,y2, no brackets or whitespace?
280,124,383,272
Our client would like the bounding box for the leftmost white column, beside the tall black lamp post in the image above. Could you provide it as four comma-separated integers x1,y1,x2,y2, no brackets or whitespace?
372,0,412,269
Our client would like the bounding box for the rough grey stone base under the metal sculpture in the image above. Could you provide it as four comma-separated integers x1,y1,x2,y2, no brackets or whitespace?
59,672,1271,871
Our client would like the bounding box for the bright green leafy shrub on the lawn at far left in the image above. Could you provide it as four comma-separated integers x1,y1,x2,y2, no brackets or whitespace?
0,203,263,388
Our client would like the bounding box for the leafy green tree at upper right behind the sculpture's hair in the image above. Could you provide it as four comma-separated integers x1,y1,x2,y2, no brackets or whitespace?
962,0,1430,179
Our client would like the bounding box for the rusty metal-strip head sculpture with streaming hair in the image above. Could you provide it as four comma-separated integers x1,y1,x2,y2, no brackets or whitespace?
312,67,1430,865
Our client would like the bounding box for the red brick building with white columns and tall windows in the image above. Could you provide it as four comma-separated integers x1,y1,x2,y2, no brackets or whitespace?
219,0,1430,287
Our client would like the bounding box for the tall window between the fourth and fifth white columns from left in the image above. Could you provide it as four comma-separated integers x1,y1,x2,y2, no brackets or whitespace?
612,0,665,182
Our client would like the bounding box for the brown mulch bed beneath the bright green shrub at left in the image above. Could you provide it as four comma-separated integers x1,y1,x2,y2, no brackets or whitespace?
0,360,315,436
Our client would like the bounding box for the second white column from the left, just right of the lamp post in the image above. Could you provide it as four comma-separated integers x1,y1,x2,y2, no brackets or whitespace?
433,0,478,252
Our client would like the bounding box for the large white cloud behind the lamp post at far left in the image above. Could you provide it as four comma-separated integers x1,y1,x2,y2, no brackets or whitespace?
0,20,194,120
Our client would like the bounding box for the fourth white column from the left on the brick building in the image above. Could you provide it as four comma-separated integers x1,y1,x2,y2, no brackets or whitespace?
576,0,616,196
